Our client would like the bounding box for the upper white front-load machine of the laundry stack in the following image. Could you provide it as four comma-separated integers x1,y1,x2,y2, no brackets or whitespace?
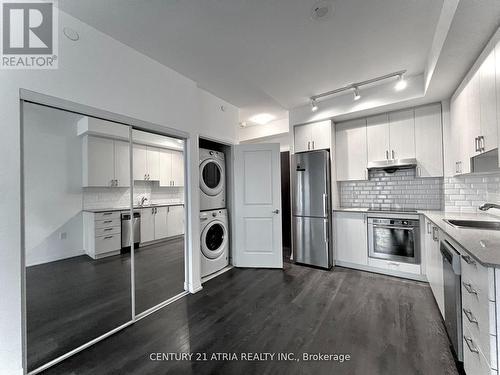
200,148,226,211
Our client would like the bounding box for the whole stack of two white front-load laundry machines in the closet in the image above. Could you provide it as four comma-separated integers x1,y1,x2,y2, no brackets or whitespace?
200,148,229,277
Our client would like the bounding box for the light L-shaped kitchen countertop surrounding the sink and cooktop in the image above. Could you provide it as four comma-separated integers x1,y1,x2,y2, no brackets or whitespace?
333,207,500,268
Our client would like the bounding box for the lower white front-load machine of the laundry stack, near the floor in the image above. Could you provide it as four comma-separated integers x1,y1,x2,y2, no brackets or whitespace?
200,210,229,277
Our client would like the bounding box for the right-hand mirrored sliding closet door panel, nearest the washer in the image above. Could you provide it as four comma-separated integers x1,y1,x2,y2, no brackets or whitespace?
132,130,185,314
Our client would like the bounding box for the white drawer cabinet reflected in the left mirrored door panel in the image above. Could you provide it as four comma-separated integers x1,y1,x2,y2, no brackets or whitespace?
83,211,121,259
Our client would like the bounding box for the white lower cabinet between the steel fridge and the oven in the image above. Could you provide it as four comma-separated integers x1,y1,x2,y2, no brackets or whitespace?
334,212,368,266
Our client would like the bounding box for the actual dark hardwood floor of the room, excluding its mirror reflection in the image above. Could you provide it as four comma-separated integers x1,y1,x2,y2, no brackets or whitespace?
42,263,457,375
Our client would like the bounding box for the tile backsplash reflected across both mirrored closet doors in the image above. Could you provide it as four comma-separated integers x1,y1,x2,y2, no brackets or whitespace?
83,181,184,209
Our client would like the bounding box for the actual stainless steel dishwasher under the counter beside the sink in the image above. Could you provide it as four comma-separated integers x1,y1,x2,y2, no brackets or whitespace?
440,240,463,362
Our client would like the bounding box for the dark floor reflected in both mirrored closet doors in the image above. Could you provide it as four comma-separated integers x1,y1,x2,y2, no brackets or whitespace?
26,238,184,370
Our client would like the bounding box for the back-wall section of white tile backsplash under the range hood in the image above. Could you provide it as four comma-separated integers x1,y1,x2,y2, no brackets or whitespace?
339,169,443,210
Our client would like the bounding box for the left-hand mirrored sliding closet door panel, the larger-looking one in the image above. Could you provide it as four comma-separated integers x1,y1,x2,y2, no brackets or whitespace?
23,103,132,371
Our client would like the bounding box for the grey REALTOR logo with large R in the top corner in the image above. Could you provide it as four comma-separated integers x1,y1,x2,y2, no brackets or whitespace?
0,0,58,69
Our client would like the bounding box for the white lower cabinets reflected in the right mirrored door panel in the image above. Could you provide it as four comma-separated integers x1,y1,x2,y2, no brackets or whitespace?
141,205,184,243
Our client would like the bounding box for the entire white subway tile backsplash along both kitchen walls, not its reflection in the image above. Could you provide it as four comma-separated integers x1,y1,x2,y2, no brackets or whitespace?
338,169,500,214
